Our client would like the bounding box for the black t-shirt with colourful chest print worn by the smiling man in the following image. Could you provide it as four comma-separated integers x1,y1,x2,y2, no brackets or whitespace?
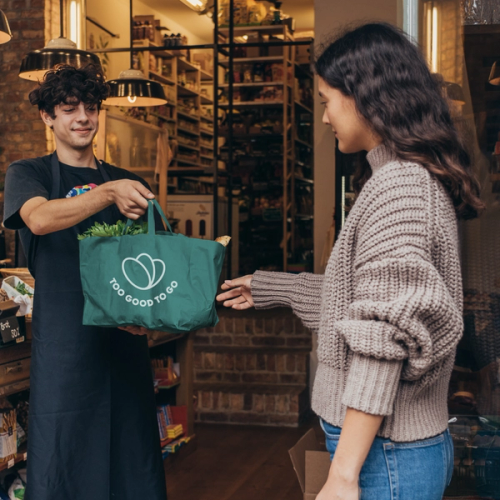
4,155,150,229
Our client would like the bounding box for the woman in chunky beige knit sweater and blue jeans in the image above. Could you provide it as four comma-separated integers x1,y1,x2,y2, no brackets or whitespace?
218,23,483,500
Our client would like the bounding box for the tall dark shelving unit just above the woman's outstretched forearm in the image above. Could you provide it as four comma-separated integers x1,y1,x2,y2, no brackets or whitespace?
218,25,314,274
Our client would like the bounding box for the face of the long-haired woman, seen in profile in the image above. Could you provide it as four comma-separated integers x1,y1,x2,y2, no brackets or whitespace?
319,77,382,153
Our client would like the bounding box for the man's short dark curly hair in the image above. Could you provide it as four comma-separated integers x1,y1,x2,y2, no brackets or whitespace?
29,64,109,118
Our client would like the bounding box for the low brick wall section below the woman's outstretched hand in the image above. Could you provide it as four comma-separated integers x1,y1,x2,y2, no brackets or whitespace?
194,308,312,426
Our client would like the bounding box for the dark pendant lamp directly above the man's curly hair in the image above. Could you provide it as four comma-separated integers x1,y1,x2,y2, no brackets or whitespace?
19,0,101,81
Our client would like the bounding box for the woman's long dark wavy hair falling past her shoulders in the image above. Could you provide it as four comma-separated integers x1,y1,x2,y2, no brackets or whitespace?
315,23,484,219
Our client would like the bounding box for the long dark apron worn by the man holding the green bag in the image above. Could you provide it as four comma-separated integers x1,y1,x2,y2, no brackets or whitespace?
26,153,166,500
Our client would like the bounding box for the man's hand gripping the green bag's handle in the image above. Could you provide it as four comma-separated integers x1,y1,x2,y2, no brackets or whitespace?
107,179,155,220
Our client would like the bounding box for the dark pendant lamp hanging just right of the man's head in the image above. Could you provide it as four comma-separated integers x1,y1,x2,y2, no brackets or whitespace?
105,0,168,107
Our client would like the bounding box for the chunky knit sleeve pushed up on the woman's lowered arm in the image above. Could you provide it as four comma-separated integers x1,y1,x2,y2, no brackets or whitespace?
335,167,462,415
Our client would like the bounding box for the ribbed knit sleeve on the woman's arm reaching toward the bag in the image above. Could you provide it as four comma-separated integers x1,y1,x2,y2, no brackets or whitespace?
251,271,324,331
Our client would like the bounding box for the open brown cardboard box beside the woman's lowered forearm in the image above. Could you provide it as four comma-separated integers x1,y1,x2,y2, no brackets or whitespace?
289,429,331,500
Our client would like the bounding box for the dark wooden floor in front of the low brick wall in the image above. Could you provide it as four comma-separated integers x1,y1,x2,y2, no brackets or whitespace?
167,422,313,500
